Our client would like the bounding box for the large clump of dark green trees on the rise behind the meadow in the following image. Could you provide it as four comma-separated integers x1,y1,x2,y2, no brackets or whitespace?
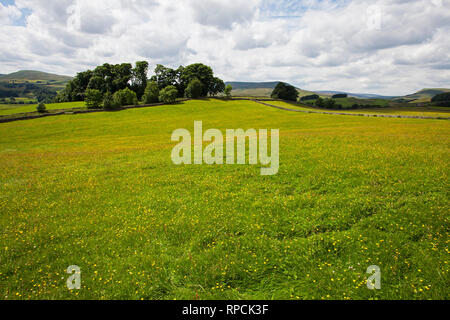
55,61,232,109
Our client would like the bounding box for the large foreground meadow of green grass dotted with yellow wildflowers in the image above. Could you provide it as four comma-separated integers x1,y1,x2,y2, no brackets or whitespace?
0,100,450,300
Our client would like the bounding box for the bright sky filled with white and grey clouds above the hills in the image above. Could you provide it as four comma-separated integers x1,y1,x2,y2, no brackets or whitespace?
0,0,450,95
